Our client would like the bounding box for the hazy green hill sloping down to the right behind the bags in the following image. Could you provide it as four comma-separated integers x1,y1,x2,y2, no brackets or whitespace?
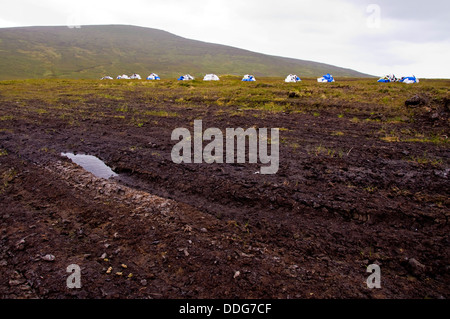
0,25,367,80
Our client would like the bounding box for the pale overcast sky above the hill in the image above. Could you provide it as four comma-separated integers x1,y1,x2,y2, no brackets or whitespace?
0,0,450,78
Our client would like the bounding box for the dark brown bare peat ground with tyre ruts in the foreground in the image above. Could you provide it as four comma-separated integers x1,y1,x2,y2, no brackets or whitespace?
0,79,450,299
